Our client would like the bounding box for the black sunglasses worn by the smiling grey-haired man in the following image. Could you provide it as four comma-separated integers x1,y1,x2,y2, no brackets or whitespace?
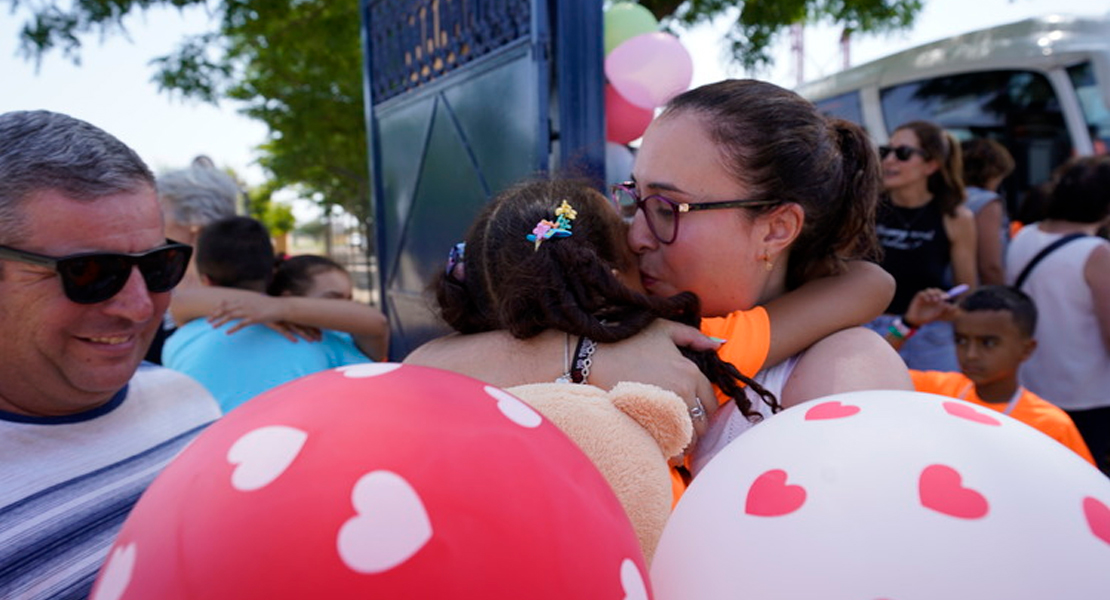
0,240,193,304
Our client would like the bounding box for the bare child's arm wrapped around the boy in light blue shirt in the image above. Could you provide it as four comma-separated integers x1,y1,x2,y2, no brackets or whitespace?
209,292,390,360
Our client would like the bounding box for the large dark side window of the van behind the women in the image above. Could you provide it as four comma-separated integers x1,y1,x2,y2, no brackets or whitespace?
880,71,1073,207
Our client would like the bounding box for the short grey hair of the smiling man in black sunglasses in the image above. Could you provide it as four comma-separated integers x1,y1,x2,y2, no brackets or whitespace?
0,111,154,243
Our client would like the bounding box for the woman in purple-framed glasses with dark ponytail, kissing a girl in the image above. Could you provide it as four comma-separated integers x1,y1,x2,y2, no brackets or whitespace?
620,80,911,470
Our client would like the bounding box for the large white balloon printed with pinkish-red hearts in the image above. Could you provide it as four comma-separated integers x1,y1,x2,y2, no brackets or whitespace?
650,390,1110,600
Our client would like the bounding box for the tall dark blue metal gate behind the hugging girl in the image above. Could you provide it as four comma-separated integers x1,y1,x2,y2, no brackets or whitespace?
361,0,605,360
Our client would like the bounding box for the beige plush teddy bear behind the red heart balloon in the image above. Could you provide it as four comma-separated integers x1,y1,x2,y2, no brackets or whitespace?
508,382,694,562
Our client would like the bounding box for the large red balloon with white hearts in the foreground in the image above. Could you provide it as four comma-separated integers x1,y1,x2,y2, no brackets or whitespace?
93,364,650,600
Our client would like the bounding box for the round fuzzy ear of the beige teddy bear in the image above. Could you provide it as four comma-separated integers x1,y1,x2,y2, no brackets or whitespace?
609,382,694,458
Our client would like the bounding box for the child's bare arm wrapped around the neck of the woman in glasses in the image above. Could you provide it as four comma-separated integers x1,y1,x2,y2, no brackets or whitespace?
765,261,895,365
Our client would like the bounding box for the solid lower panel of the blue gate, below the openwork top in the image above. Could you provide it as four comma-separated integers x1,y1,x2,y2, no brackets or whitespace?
377,43,547,356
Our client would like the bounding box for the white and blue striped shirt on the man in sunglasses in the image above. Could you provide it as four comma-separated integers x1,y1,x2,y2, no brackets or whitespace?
0,363,220,600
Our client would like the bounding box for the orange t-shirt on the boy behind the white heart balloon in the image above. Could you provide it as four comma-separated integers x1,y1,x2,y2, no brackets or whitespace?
909,369,1094,465
